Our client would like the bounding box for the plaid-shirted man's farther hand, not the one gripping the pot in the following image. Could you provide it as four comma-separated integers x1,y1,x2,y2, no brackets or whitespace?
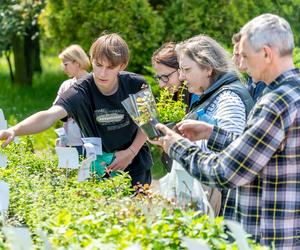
175,120,213,141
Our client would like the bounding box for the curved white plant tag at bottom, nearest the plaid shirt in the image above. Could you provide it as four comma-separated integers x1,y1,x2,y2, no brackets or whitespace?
224,220,250,250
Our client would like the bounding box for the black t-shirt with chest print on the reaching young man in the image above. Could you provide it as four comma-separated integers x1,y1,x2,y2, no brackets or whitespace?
55,71,152,170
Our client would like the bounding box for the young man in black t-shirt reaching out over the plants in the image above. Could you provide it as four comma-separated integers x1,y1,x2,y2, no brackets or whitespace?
0,34,152,185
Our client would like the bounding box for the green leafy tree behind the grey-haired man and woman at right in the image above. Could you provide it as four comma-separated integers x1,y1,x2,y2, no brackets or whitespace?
163,0,300,47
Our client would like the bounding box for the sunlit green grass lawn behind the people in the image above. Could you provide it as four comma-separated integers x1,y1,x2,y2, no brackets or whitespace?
0,57,165,179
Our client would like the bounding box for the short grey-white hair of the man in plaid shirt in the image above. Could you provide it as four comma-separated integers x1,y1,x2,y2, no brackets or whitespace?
240,14,295,56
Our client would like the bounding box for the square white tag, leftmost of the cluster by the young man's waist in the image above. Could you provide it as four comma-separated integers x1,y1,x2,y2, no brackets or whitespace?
55,147,79,169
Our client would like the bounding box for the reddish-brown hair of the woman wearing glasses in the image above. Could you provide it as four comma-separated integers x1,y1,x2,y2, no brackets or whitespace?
151,42,179,69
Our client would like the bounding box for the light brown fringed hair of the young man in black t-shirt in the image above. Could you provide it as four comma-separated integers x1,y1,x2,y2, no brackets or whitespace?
90,33,129,67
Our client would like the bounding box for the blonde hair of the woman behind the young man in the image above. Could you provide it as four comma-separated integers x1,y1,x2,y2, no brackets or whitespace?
58,44,91,70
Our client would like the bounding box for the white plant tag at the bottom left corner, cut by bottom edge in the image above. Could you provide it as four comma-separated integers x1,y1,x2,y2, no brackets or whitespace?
2,227,33,250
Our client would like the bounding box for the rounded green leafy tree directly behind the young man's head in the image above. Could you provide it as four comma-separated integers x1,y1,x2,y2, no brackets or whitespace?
42,0,164,72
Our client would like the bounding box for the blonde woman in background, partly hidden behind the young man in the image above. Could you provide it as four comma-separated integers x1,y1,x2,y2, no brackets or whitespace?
54,44,90,155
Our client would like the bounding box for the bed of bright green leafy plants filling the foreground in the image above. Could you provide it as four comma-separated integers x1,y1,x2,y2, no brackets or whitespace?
0,141,268,249
